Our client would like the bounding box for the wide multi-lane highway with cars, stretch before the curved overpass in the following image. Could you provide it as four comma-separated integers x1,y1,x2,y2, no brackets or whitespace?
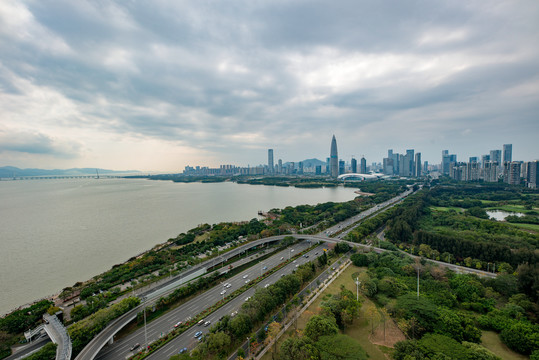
96,241,320,360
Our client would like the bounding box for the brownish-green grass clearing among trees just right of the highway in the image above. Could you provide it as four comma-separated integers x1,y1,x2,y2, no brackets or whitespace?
262,265,390,360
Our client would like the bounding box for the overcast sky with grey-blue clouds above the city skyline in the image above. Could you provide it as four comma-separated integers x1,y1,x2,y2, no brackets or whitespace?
0,0,539,172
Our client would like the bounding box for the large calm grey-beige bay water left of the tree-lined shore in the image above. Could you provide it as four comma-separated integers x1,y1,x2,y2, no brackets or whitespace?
0,179,354,314
